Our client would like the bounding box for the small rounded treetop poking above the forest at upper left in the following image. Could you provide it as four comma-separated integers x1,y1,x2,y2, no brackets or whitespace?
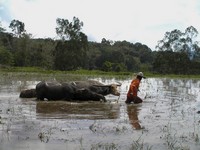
9,19,26,37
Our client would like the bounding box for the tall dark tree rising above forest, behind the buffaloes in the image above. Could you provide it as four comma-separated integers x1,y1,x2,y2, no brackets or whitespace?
54,17,88,70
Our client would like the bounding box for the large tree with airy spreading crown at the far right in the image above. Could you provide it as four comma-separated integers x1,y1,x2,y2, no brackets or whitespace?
153,26,200,74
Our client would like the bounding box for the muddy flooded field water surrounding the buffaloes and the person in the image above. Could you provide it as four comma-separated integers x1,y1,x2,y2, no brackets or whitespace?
0,78,200,150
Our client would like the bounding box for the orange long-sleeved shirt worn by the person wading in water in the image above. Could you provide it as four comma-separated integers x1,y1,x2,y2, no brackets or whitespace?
127,78,140,96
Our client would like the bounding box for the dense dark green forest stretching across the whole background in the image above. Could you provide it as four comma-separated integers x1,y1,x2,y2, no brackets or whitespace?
0,17,200,74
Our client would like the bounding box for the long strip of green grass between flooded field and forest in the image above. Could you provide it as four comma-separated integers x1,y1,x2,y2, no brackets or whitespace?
0,67,200,79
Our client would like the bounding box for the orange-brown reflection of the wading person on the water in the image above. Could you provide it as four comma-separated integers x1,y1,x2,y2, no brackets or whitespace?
127,105,141,130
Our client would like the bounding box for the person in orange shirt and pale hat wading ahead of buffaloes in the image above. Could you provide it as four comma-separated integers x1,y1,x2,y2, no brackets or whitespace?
126,72,146,104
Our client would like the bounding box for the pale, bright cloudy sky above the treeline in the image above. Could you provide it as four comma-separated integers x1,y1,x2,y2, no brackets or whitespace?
0,0,200,50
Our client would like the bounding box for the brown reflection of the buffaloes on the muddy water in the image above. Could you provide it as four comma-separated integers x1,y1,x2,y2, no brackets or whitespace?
36,101,120,119
